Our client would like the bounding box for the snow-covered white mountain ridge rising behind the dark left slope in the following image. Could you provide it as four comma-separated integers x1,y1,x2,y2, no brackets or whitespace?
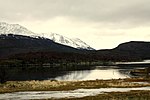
0,22,94,50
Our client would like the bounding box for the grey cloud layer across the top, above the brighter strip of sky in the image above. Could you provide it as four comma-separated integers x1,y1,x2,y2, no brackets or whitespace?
0,0,150,25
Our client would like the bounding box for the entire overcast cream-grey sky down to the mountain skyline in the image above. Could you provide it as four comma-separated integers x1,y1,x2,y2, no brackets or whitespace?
0,0,150,49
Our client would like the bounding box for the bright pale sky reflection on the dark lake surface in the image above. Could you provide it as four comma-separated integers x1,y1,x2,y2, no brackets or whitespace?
49,66,130,81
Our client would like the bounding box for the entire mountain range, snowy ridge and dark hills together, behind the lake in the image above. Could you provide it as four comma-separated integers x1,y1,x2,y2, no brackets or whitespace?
0,23,150,61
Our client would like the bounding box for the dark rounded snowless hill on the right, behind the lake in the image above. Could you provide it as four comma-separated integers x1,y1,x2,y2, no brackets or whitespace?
97,41,150,61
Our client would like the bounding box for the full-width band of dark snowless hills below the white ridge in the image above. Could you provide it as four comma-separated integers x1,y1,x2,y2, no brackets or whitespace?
0,34,150,61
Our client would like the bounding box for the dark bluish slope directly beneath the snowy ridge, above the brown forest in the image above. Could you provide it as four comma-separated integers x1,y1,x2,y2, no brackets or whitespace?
0,34,82,57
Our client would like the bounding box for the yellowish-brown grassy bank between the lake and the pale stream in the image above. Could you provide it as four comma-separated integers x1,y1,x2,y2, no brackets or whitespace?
0,78,150,93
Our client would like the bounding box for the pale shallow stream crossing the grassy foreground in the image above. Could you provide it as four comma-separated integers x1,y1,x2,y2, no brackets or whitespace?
0,87,150,100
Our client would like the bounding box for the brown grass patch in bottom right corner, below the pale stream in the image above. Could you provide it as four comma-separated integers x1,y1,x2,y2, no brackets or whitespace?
60,90,150,100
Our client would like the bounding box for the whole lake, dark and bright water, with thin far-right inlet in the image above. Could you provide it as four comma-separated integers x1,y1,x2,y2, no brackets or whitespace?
3,60,150,81
